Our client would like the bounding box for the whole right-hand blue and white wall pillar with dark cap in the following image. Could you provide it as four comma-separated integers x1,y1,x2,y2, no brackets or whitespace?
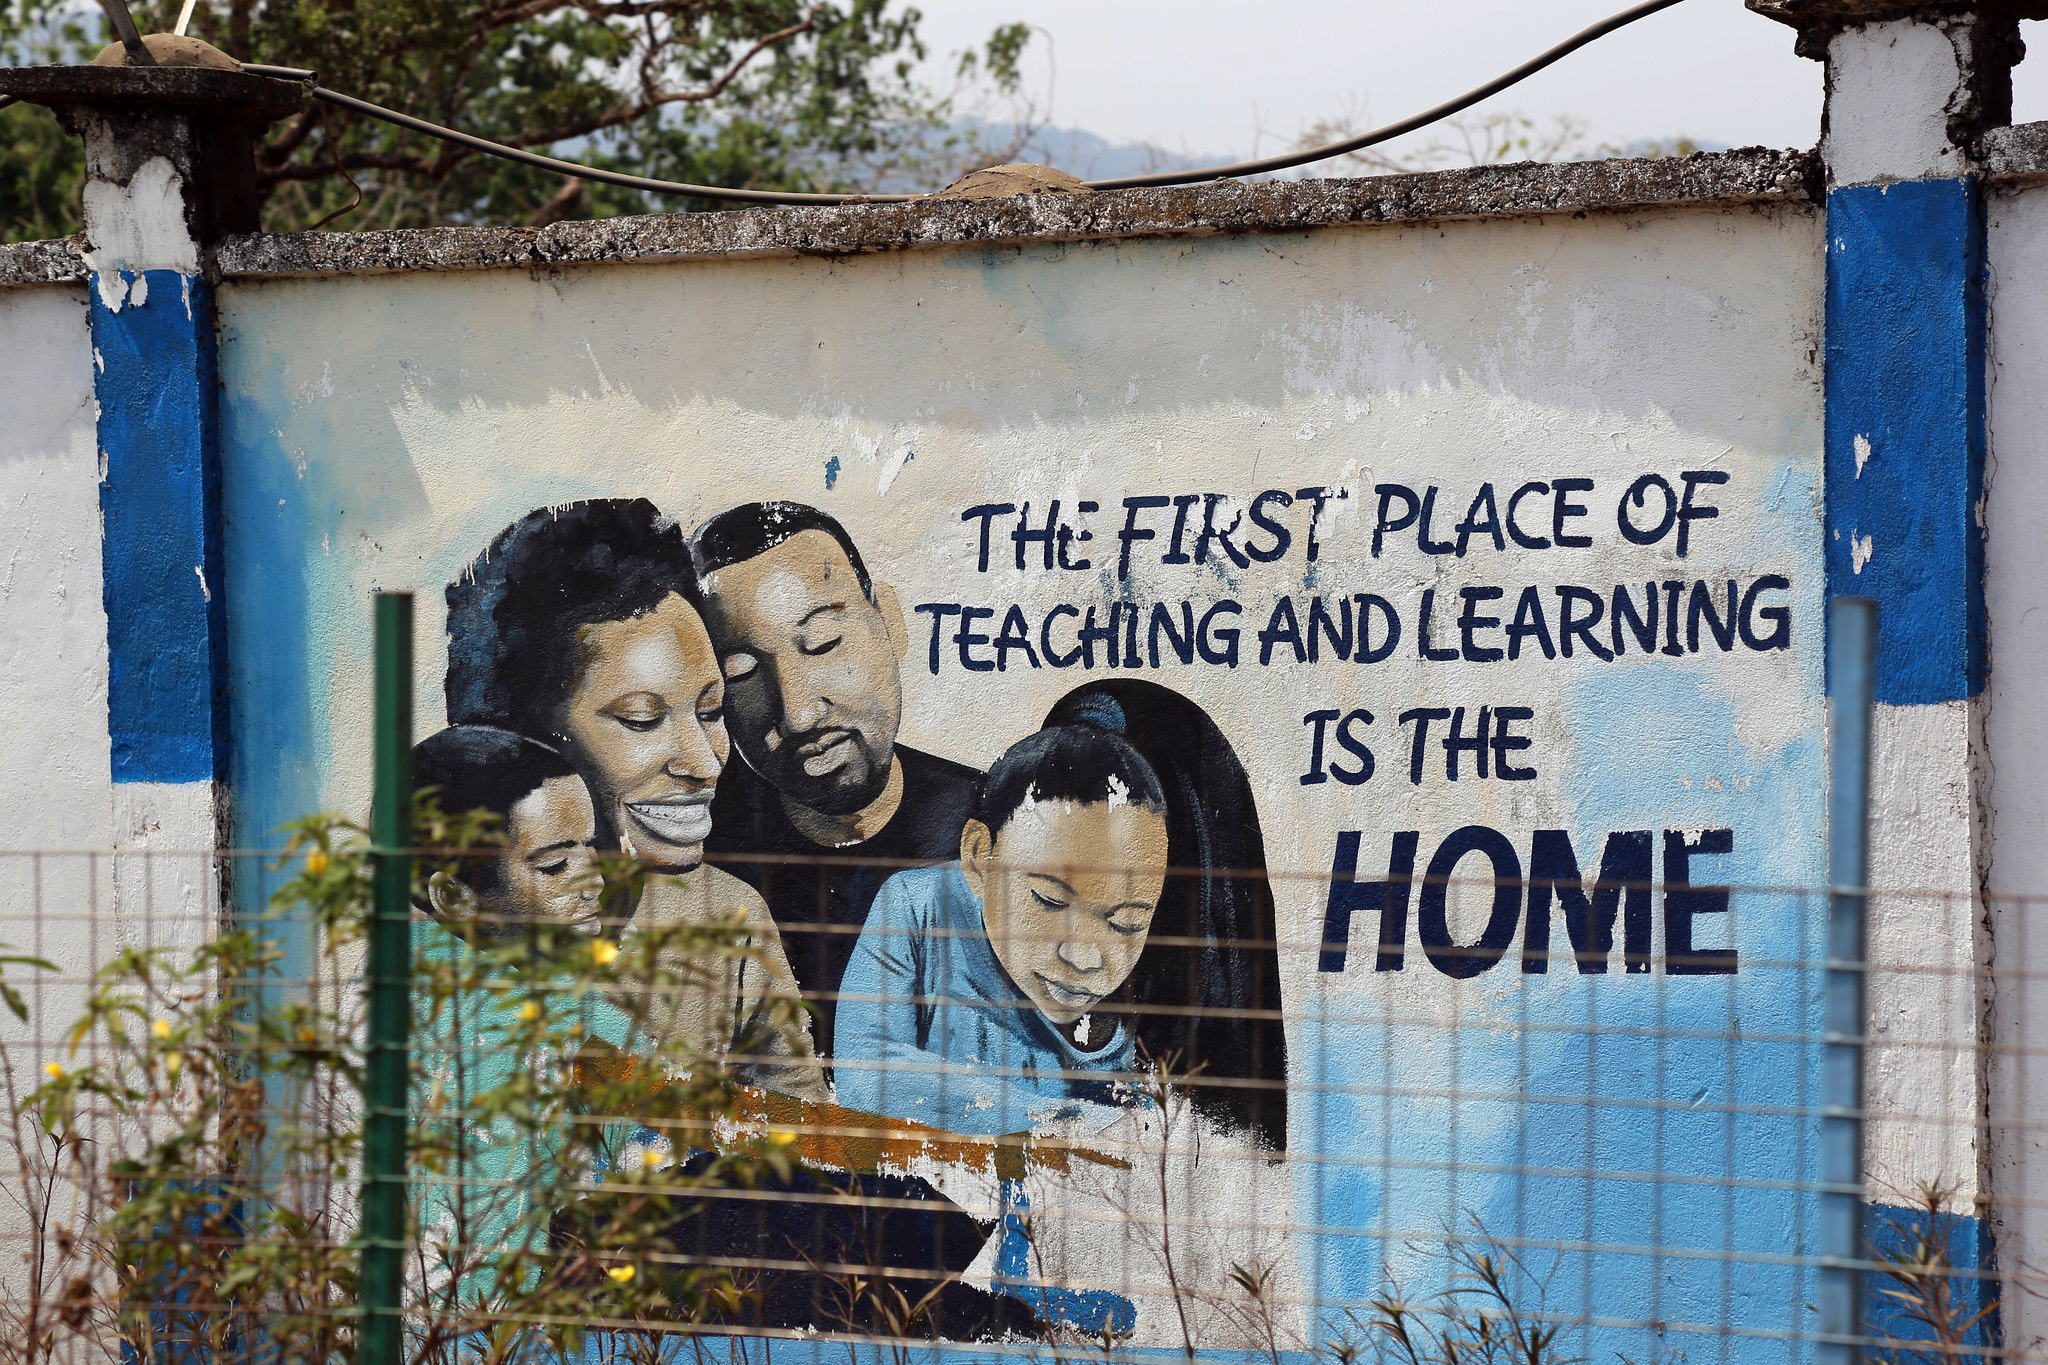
1749,0,2048,1340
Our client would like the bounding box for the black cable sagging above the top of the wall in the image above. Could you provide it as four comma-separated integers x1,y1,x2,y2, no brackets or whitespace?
243,0,1681,205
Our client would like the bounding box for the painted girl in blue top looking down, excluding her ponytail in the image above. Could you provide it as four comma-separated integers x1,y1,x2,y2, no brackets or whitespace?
834,724,1167,1136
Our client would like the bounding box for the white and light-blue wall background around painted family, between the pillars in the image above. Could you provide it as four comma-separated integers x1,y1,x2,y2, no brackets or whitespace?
207,197,1825,1353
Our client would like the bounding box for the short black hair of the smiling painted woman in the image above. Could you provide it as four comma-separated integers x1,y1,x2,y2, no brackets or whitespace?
446,497,700,739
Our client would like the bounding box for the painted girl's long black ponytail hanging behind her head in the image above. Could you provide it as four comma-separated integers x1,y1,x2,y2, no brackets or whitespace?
1047,679,1286,1152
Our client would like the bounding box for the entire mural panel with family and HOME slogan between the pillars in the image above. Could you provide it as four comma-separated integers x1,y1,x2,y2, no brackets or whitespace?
223,213,1825,1361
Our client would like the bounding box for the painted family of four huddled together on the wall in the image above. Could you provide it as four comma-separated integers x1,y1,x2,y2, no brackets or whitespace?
416,499,1286,1338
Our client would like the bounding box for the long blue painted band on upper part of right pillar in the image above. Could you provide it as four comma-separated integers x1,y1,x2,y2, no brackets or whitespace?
1827,180,1985,704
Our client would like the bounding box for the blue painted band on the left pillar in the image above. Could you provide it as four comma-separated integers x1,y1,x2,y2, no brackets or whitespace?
90,270,227,782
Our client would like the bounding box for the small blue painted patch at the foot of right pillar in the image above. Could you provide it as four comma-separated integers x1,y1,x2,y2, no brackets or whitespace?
1864,1203,2003,1359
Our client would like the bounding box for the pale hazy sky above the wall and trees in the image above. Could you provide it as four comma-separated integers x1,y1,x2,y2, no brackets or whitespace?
920,0,2048,167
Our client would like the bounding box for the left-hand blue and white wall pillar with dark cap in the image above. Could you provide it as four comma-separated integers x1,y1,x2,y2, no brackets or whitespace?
0,56,301,945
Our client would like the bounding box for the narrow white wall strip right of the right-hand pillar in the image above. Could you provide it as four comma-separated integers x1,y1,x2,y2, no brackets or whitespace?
1985,179,2048,1351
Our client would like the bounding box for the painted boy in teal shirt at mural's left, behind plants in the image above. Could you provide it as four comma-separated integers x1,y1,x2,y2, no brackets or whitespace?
414,726,823,1304
